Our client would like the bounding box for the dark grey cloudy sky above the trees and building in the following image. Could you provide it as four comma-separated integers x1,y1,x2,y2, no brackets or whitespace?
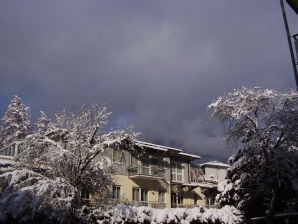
0,0,298,161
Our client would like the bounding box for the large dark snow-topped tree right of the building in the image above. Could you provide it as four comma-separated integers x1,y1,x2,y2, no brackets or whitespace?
209,88,298,220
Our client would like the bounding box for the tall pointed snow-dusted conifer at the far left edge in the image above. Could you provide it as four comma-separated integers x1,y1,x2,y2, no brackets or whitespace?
0,95,30,145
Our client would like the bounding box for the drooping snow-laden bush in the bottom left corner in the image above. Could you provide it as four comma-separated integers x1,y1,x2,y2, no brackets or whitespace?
0,164,76,223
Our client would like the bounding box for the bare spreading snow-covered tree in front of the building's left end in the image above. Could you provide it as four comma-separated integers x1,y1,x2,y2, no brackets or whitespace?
18,104,134,205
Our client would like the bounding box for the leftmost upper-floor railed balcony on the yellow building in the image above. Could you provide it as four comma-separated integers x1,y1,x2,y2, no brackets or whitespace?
128,165,165,179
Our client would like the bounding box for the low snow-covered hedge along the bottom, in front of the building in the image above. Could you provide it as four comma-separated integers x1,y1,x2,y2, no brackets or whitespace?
82,205,243,224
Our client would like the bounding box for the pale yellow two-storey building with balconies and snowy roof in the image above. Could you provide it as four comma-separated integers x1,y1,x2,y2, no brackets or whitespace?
0,141,228,208
